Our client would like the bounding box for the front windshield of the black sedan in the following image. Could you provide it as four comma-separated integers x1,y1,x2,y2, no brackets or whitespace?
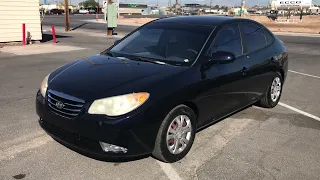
106,23,213,66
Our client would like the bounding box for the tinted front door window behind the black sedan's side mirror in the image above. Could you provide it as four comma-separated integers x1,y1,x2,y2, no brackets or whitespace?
208,24,242,56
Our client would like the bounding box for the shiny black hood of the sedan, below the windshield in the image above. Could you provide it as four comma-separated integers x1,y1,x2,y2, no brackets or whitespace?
48,55,185,101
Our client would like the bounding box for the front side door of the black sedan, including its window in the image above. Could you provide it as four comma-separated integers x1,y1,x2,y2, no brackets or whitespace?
197,24,248,126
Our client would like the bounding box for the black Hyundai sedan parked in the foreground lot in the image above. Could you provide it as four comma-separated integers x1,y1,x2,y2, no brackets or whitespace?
36,16,288,162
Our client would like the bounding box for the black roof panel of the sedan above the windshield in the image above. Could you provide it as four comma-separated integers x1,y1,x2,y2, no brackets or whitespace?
154,15,240,26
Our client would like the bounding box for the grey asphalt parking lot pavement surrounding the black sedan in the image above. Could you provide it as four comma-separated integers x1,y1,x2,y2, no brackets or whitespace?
0,33,320,180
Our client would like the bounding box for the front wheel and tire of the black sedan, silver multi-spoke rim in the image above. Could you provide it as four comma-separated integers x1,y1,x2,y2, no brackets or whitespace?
152,105,197,163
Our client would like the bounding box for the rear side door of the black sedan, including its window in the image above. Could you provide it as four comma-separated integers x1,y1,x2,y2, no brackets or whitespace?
241,22,274,101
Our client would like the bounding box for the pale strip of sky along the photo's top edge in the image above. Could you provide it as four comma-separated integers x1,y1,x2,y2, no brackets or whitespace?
40,0,269,5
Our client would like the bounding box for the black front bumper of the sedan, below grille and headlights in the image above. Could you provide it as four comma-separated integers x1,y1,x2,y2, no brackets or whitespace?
36,92,160,158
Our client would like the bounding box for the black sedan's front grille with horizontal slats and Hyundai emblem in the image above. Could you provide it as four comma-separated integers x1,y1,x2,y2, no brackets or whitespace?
47,90,85,119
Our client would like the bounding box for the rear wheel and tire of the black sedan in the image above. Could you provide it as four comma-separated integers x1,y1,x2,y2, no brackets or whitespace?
257,72,283,108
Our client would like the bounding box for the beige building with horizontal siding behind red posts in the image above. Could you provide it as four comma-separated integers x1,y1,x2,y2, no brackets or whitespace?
0,0,42,42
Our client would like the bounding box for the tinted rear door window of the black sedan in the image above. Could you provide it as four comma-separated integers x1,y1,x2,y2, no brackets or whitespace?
242,23,267,52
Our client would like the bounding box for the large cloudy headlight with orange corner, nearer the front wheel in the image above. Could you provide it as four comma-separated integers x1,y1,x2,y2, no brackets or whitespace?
88,92,149,116
